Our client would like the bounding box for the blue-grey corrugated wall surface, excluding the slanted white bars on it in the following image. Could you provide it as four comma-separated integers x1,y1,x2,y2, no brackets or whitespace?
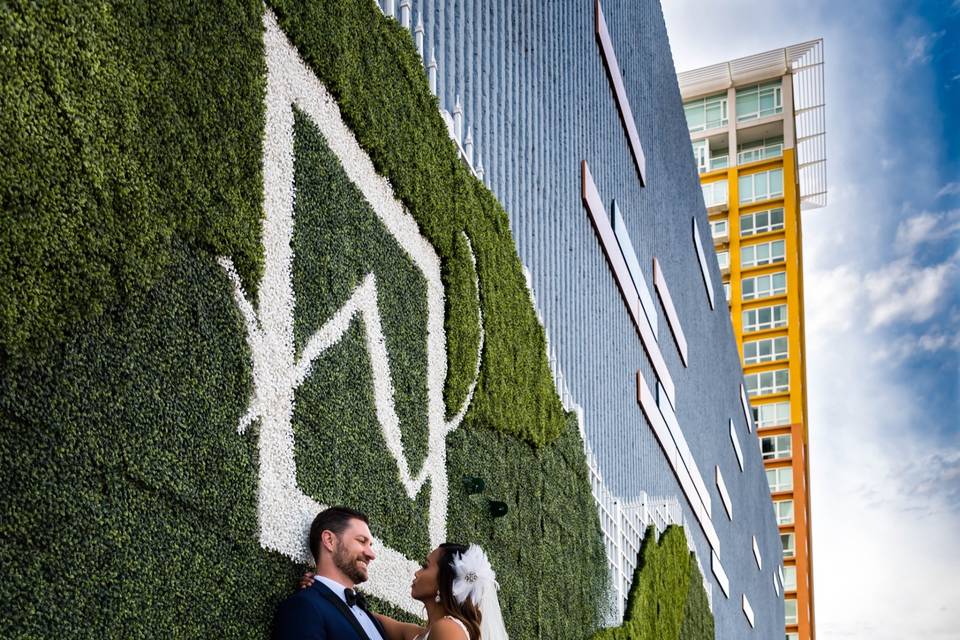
378,0,783,638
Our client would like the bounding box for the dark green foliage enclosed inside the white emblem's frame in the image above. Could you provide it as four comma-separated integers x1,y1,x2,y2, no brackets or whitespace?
293,112,430,558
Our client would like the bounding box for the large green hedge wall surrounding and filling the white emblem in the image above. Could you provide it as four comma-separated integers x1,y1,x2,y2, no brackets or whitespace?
0,0,606,638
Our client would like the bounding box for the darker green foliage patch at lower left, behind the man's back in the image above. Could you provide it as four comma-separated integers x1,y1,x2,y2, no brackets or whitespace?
0,246,298,638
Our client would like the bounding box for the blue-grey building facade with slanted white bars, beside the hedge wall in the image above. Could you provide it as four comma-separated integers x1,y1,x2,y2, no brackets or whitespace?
416,0,801,638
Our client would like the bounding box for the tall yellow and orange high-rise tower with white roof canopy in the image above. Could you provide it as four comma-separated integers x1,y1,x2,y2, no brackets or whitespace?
679,40,826,640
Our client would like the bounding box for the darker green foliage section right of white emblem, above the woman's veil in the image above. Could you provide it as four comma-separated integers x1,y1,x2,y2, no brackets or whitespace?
447,417,607,638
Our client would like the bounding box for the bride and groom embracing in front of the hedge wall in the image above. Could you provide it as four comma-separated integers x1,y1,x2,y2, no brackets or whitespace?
273,507,508,640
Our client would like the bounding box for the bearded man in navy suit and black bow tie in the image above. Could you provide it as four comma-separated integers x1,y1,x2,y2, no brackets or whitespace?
273,507,387,640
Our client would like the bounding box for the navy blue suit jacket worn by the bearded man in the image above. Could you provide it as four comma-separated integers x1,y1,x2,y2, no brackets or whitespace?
273,581,387,640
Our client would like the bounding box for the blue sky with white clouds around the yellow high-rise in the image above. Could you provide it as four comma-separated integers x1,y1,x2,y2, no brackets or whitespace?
662,0,960,640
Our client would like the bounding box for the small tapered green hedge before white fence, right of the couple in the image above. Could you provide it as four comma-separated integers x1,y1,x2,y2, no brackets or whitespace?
593,525,713,640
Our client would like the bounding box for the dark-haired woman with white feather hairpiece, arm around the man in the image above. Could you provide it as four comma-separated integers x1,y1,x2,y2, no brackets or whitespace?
300,542,508,640
